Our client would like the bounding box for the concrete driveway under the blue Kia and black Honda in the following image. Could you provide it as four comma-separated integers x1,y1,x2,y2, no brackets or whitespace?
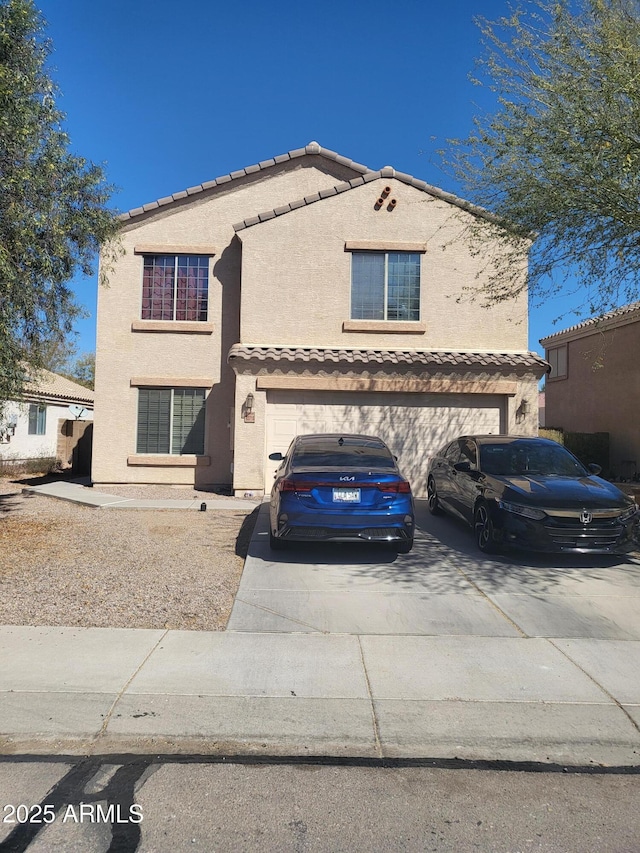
227,501,640,641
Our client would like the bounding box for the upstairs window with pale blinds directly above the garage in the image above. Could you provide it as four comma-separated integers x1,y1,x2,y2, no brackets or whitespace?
351,252,420,320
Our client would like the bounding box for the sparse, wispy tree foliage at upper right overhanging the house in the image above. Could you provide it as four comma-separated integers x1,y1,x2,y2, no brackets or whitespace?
445,0,640,315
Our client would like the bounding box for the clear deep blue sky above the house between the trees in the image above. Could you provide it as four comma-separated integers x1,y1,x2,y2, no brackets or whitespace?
36,0,575,352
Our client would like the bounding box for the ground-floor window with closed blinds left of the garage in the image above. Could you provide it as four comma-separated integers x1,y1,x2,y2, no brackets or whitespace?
136,388,205,456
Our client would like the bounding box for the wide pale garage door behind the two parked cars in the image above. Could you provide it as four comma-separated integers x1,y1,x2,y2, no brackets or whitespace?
265,391,505,496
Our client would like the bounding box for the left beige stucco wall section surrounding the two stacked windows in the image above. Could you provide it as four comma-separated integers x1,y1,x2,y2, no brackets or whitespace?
92,157,360,485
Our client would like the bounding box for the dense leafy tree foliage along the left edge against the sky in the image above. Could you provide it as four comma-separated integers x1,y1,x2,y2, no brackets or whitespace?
0,0,118,406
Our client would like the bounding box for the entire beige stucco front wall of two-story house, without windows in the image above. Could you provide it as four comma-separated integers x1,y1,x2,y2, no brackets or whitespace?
92,157,537,494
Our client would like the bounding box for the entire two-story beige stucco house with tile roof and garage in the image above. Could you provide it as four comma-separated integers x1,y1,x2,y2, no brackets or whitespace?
92,142,546,494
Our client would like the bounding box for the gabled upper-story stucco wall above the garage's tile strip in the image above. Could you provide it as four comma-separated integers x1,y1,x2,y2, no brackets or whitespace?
239,178,528,351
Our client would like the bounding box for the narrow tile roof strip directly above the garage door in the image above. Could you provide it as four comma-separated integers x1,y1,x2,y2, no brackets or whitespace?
227,344,547,370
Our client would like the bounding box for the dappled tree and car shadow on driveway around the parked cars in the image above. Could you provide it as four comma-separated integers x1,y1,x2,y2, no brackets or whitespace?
236,501,640,594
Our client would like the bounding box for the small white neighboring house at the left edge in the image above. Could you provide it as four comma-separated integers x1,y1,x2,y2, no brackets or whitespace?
0,370,94,461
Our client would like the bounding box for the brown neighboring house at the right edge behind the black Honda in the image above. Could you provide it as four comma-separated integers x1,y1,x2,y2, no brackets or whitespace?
540,302,640,478
